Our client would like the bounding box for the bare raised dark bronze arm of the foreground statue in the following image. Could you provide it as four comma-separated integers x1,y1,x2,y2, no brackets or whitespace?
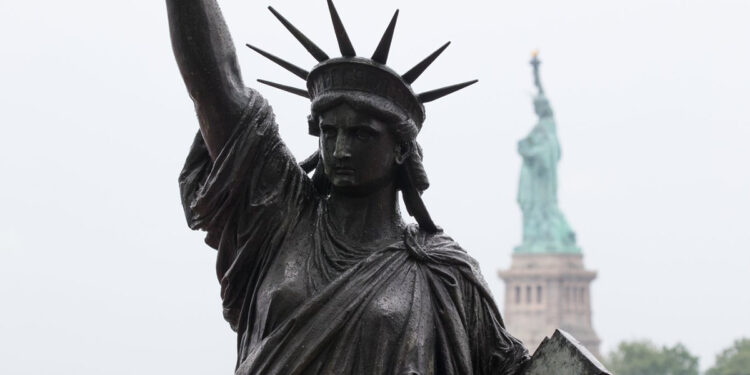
167,0,249,159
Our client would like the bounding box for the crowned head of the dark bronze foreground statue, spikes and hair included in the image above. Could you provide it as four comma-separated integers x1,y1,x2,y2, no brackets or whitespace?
248,0,477,231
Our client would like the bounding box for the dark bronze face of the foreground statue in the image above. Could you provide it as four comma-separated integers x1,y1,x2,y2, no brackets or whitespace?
320,104,401,193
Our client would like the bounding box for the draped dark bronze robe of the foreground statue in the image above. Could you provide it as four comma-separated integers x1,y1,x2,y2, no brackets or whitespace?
180,91,528,375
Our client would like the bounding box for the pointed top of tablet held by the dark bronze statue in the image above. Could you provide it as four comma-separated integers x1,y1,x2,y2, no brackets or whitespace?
524,329,612,375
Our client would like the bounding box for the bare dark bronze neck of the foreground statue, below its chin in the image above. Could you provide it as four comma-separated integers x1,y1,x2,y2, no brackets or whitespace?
327,184,404,246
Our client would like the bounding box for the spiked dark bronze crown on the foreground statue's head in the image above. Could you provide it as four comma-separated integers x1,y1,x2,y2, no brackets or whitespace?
247,0,477,129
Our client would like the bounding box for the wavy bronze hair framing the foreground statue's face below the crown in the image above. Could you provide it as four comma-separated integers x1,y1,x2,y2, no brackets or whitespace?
308,92,430,195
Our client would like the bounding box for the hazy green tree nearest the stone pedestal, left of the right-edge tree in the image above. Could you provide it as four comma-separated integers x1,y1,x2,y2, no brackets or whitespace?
605,340,699,375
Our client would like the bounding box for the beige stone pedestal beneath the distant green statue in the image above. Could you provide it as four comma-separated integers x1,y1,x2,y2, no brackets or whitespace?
499,253,600,357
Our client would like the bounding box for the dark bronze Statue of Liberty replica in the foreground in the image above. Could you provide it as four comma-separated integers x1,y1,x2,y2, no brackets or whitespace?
167,0,612,375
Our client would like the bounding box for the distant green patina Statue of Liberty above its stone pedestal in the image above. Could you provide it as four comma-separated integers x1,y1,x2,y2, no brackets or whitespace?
515,53,581,253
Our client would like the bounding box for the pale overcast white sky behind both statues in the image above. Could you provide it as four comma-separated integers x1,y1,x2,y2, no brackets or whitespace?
0,0,750,375
